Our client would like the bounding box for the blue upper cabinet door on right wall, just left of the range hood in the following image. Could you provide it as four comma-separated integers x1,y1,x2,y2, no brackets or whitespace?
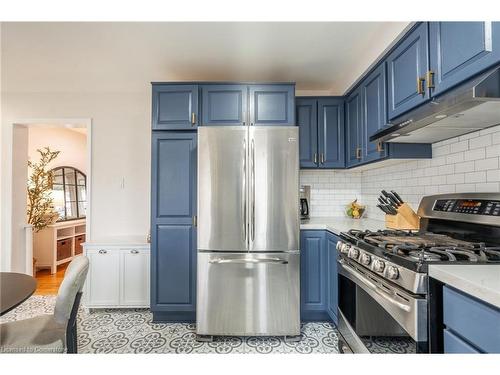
361,63,387,162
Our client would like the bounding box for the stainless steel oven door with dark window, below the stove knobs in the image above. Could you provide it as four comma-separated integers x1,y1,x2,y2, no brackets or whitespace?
338,256,427,353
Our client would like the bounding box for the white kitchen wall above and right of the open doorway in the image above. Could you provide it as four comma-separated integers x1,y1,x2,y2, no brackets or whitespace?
2,92,151,244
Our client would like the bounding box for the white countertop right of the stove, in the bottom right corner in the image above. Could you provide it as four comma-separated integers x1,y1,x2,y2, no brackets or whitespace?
429,264,500,308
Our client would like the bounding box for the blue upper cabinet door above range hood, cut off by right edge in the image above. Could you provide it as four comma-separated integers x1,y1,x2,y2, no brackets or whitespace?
429,22,500,95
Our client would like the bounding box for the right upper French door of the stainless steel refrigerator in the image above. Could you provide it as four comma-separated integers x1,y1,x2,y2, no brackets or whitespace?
248,126,300,252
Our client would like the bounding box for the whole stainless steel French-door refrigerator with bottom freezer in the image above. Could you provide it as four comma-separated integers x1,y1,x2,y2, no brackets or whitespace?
196,126,300,336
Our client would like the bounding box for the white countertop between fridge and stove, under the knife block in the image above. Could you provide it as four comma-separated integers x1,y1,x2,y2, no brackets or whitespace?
300,217,385,235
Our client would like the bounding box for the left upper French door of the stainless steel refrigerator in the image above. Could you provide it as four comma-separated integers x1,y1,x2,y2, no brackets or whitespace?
198,126,248,251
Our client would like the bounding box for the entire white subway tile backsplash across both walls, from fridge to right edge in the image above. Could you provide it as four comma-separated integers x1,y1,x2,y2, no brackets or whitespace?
300,125,500,219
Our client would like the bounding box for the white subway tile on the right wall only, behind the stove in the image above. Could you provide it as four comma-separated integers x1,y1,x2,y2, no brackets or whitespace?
361,126,500,219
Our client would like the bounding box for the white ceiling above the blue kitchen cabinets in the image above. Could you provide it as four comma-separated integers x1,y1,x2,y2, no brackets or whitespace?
1,22,408,95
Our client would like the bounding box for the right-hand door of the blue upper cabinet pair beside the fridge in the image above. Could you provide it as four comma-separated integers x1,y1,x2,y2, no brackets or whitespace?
318,98,345,168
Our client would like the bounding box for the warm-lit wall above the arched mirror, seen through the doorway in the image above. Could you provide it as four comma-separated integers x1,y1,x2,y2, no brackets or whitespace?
28,126,87,174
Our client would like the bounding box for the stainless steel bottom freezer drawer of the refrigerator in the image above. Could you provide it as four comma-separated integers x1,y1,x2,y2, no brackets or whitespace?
196,252,300,336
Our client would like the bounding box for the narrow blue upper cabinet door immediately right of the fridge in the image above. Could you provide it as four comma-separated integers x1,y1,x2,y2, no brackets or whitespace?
295,98,318,168
